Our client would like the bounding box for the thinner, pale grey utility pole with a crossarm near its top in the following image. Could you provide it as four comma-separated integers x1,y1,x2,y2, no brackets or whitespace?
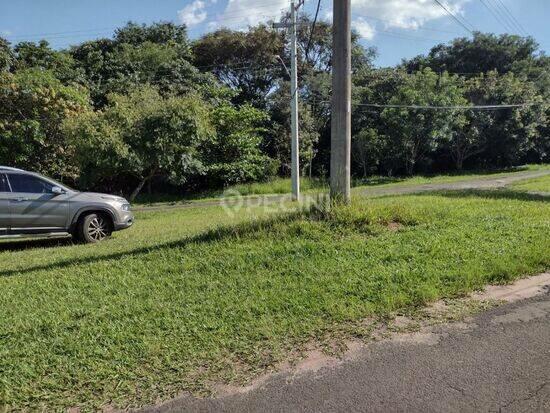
273,0,304,201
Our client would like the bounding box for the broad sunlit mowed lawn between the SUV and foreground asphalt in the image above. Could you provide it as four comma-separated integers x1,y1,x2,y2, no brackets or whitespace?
0,191,550,411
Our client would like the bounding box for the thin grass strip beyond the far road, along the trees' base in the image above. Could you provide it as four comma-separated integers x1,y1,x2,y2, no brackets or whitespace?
135,165,550,205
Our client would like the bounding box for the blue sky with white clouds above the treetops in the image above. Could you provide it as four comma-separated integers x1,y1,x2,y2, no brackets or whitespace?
0,0,550,66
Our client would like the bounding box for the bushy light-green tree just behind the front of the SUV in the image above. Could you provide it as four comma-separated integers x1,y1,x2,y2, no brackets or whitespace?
65,86,213,200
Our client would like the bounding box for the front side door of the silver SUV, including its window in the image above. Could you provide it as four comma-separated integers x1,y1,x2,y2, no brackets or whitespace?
7,173,69,234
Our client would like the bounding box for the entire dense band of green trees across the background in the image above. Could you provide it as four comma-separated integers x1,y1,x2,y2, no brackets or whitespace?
0,20,550,193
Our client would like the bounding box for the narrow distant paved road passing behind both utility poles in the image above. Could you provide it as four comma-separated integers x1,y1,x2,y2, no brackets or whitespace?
134,170,550,211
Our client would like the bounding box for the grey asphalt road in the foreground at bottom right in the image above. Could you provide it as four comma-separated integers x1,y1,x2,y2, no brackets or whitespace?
144,293,550,413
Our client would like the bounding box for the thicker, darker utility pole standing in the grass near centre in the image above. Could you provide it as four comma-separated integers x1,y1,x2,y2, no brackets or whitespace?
330,0,351,203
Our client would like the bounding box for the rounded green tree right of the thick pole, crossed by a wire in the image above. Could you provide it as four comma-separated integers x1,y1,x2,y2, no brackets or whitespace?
382,69,467,175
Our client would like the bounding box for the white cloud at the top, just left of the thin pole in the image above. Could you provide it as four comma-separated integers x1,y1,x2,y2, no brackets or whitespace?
218,0,289,27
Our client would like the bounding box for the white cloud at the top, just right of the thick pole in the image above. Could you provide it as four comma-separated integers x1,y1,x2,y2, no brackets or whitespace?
352,0,470,29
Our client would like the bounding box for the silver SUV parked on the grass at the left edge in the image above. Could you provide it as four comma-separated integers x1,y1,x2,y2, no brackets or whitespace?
0,166,134,243
